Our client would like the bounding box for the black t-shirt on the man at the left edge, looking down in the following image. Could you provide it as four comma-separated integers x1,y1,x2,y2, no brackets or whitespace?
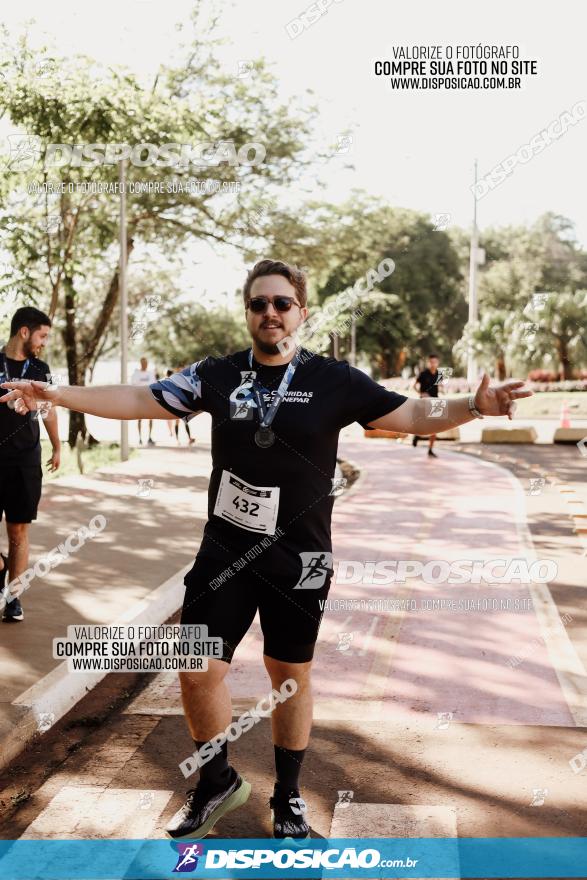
0,352,51,467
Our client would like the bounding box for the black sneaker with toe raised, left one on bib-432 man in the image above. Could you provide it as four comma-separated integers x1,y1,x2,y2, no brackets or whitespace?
165,771,251,840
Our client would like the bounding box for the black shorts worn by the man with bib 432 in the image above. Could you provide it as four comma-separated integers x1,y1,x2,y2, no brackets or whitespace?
181,556,332,663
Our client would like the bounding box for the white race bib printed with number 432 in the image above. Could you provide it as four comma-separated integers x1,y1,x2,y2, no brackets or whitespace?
214,470,279,535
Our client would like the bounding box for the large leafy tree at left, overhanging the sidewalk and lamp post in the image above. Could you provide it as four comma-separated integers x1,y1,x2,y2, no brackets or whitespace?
0,3,320,445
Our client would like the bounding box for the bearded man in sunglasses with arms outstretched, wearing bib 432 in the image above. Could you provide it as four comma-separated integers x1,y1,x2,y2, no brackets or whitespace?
0,260,532,838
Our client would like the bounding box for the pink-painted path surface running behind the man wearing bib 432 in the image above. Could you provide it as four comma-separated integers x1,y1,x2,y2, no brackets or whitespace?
136,440,579,726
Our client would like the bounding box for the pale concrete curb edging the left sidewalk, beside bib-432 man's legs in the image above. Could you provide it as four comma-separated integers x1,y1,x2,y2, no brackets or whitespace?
0,562,193,768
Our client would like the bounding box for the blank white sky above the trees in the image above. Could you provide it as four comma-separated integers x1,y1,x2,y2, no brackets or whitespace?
0,0,587,295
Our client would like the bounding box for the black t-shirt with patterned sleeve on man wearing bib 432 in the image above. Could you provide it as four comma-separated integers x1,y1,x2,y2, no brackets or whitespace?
150,349,407,571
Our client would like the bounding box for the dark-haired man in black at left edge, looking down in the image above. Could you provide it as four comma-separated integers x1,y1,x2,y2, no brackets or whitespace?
0,306,61,623
